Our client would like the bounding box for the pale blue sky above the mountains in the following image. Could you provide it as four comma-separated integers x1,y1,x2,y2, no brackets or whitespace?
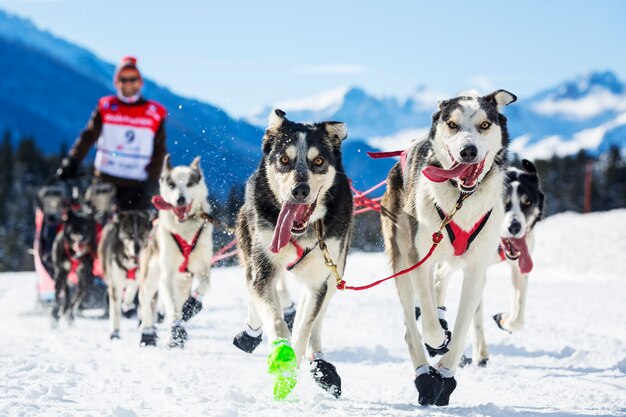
0,0,626,115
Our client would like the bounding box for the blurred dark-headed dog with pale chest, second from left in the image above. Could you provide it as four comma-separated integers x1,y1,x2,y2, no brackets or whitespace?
98,210,152,339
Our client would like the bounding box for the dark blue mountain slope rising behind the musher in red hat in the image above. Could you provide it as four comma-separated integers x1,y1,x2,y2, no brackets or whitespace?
0,10,262,197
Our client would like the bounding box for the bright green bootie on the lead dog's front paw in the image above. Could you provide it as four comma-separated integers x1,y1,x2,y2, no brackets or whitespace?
267,339,298,400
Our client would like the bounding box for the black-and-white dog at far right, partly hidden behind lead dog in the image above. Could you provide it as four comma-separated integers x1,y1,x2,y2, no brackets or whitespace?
435,159,545,366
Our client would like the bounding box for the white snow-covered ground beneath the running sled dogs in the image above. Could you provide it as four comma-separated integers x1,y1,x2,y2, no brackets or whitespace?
0,210,626,417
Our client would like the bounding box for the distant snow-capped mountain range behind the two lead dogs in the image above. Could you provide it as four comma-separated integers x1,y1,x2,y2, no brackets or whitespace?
247,71,626,158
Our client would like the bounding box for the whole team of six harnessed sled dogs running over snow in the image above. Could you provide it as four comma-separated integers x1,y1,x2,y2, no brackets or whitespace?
52,90,544,406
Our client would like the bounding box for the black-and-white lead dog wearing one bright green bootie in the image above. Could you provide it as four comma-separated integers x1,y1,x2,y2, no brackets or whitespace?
237,109,352,399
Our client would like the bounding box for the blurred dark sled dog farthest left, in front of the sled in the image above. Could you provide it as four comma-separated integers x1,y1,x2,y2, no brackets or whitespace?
52,209,96,327
